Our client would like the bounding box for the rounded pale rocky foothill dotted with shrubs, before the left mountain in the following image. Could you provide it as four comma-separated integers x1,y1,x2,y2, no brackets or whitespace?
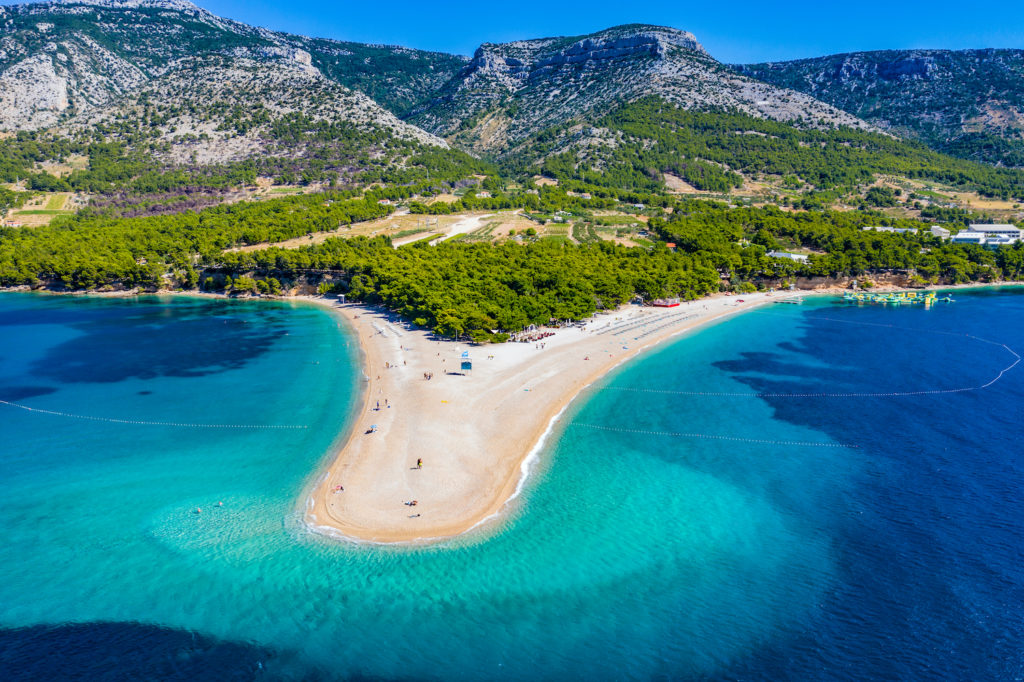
58,56,447,166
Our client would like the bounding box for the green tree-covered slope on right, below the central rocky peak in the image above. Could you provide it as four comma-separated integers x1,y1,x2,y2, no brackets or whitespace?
526,97,1024,198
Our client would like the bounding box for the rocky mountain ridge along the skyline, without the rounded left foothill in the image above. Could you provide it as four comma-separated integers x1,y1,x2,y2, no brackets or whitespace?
0,0,1024,175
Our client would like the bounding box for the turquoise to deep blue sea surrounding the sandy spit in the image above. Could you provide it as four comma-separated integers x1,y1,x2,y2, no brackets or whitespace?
0,290,1024,680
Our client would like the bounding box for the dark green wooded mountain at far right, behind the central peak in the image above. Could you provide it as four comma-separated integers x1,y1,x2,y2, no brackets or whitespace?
734,49,1024,167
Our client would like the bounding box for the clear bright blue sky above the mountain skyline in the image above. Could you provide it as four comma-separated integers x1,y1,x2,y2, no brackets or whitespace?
2,0,1024,62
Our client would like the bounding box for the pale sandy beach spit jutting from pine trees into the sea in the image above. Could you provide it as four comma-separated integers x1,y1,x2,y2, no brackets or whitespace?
305,292,799,543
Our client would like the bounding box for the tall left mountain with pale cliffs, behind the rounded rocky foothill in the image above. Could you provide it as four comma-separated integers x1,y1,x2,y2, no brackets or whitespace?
0,0,465,130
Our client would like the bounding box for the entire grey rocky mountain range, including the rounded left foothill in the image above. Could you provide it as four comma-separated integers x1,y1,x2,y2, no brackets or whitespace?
6,0,1024,188
